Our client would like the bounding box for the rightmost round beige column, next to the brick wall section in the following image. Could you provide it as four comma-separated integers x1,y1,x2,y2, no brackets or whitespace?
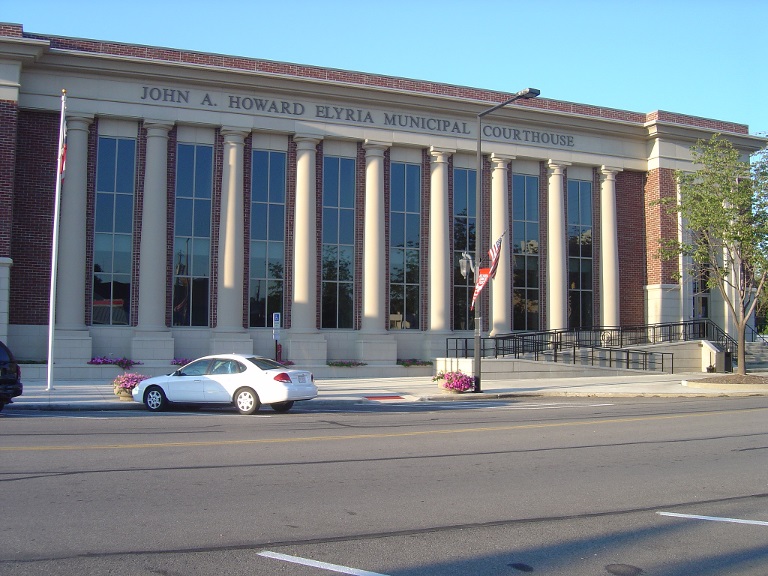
600,166,621,326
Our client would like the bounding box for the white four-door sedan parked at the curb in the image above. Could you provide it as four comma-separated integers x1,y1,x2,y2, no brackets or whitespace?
132,354,317,414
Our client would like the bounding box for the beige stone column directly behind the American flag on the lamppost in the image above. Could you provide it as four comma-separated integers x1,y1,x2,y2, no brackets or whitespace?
488,154,515,336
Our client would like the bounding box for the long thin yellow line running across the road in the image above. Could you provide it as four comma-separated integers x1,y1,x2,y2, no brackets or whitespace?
0,408,768,453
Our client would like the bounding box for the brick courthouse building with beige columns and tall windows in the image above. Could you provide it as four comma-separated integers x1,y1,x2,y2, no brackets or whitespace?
0,24,764,366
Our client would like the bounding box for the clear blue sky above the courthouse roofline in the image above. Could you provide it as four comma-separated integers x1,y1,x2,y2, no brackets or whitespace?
6,0,768,135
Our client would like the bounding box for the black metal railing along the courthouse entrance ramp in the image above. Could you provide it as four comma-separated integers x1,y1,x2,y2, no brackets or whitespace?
446,320,736,372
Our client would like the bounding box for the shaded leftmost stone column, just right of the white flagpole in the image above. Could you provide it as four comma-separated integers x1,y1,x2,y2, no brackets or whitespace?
55,115,93,362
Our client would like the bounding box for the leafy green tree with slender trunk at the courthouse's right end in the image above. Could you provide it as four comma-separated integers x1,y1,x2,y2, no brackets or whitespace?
661,134,768,374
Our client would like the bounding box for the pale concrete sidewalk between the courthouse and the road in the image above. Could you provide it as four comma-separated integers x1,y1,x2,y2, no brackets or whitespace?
3,373,768,413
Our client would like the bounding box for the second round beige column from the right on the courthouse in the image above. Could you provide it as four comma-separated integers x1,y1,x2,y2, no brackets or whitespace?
547,160,570,330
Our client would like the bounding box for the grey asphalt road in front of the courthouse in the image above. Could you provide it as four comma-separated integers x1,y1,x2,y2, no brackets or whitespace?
0,397,768,576
